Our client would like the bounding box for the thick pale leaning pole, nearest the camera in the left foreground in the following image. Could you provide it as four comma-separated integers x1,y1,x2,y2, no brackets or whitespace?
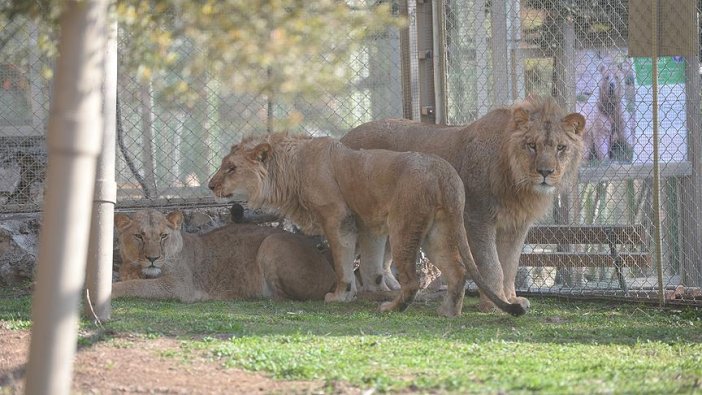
25,0,108,395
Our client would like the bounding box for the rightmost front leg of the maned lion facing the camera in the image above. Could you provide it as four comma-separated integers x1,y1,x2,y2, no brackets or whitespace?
497,225,529,306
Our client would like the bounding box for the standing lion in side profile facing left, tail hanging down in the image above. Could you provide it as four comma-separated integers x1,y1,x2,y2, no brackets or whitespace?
209,133,528,316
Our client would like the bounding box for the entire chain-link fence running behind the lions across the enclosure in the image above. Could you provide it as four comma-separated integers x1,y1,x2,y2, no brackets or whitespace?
0,0,702,301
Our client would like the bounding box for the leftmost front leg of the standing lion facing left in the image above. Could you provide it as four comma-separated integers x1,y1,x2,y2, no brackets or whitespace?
323,215,357,302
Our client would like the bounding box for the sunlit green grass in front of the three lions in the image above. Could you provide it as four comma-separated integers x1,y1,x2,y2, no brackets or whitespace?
0,288,702,394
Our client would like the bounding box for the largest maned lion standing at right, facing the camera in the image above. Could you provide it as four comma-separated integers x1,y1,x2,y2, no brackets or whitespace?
341,97,585,312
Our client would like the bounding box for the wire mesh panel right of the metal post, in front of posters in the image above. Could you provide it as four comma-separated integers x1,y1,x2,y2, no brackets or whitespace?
446,0,702,301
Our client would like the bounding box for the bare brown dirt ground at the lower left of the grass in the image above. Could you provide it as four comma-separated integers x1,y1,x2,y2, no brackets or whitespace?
0,323,363,394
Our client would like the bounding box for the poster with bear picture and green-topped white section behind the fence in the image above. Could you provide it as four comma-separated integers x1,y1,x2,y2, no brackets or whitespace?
576,49,687,165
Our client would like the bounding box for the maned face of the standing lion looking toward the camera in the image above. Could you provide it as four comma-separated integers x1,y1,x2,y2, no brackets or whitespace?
508,103,585,193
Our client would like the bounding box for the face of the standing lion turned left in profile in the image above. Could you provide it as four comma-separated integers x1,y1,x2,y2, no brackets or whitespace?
208,143,270,201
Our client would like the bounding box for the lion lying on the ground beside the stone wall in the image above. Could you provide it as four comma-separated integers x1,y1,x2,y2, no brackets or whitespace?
112,209,336,303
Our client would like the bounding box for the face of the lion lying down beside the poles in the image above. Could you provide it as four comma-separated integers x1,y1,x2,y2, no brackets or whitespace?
115,209,183,278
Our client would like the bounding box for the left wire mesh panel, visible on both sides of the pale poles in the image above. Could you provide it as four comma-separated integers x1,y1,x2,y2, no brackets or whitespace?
0,2,402,212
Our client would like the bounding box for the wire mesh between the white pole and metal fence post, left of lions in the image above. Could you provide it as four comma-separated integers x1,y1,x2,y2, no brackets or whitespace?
117,5,402,207
